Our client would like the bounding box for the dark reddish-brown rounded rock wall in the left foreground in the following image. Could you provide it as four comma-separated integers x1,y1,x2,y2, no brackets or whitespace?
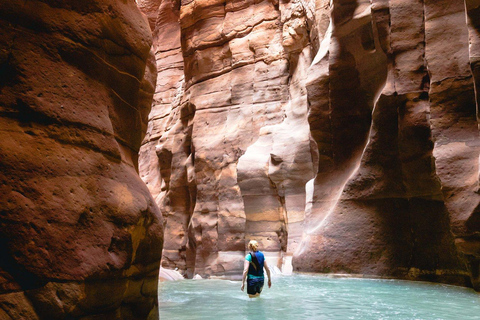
0,0,163,319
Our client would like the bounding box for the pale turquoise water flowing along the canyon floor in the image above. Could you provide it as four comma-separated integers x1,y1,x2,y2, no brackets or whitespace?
159,275,480,320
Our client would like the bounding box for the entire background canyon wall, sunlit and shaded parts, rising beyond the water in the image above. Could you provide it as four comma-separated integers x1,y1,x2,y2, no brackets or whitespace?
140,0,480,288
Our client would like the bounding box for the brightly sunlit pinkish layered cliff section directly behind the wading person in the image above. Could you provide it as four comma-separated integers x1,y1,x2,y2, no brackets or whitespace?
140,1,313,276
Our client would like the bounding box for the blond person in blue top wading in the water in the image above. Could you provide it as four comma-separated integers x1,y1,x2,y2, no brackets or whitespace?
241,240,272,298
